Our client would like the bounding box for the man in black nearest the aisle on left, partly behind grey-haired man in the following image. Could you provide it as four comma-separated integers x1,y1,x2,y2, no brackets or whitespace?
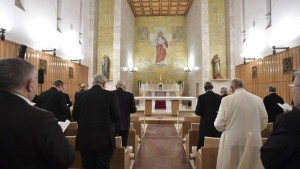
114,80,136,147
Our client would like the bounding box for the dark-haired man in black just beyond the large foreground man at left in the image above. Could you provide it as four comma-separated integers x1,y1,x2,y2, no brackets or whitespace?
36,80,67,121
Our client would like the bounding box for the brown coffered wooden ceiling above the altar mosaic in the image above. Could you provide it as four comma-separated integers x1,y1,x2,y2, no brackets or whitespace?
127,0,193,16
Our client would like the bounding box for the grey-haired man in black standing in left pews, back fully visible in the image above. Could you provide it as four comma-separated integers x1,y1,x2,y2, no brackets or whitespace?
73,74,120,169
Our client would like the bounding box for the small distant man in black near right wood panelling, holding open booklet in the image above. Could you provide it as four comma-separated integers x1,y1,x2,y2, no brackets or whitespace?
264,86,284,123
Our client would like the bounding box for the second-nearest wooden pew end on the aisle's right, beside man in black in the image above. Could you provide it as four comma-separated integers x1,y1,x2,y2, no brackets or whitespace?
185,123,200,157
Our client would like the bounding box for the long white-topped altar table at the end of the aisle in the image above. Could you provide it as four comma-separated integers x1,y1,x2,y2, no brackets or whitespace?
134,96,197,116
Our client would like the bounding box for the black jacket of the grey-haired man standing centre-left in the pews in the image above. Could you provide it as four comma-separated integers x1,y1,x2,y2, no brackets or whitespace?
73,85,120,151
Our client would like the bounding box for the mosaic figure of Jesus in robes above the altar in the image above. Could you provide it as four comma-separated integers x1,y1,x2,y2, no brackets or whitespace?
155,31,168,65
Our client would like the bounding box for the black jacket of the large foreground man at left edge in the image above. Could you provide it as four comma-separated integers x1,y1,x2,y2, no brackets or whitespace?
0,91,74,169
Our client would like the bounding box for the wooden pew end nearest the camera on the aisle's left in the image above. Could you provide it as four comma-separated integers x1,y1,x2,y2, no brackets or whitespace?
109,137,131,169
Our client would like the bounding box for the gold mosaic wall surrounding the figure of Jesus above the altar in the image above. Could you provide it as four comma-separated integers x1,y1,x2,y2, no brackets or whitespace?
134,16,188,83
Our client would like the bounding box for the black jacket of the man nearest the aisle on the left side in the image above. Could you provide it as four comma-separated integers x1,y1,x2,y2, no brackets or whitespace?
114,88,136,130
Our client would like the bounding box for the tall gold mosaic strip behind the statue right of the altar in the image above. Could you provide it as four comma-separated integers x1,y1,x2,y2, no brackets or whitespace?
208,0,227,79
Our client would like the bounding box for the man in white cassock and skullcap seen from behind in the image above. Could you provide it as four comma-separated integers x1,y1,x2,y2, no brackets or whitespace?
214,79,268,169
